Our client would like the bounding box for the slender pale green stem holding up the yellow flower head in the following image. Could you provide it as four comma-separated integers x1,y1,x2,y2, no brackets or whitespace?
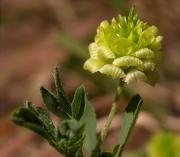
93,79,124,156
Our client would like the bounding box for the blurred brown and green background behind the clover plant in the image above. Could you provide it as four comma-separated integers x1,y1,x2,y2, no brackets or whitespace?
0,0,180,157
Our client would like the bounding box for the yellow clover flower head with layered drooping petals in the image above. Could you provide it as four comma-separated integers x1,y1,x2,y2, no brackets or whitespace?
84,9,162,85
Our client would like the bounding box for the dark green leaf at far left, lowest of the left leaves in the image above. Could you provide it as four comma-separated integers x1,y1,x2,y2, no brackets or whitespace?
11,102,57,143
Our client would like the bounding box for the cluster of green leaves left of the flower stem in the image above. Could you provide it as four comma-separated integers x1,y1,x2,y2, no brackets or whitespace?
12,68,96,157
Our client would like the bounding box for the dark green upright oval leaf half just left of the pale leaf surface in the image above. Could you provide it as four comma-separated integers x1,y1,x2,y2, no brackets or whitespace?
71,86,85,120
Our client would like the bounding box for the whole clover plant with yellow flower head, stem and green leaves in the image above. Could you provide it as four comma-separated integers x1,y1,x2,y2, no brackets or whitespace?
12,9,162,157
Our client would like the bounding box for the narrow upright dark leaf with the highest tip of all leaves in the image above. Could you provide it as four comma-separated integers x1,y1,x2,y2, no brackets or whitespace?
53,67,72,115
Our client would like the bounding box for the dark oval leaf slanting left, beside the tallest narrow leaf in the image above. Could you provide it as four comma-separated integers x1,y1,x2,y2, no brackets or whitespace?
40,87,70,119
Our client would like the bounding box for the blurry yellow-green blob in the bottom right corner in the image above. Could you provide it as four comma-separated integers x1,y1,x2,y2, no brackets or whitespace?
124,132,180,157
